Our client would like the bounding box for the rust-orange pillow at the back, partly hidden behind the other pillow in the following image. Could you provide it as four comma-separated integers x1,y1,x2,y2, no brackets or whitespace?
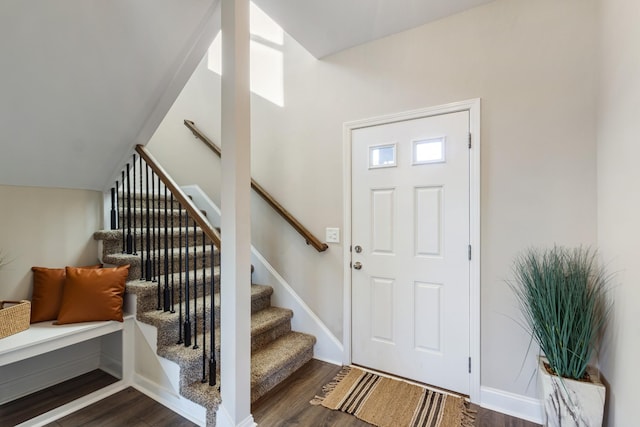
31,264,102,323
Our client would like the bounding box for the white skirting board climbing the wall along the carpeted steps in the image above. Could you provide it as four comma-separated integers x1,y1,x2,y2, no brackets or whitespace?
181,185,344,365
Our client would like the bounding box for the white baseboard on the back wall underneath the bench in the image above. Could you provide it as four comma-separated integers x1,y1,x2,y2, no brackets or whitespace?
0,340,100,405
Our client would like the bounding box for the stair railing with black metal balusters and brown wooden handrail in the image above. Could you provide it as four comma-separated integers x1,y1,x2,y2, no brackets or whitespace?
110,145,221,386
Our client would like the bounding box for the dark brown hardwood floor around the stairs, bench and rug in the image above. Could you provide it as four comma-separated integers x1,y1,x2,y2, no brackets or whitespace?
0,360,537,427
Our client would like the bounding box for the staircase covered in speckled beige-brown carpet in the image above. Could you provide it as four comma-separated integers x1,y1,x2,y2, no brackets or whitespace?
94,186,316,426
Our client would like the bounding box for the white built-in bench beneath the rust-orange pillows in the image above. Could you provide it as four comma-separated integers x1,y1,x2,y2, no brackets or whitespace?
0,314,134,426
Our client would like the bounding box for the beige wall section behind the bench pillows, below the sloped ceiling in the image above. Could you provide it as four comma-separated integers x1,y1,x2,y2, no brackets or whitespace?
0,185,103,299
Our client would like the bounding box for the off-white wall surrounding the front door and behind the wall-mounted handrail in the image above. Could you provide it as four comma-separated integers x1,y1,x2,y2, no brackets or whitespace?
149,0,597,404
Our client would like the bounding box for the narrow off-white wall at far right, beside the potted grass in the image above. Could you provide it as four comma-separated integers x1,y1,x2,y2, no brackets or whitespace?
598,0,640,427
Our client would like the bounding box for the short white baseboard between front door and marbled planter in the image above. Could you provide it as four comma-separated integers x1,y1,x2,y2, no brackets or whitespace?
480,386,543,424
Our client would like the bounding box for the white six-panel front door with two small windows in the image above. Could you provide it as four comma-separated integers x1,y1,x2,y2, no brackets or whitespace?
351,111,470,394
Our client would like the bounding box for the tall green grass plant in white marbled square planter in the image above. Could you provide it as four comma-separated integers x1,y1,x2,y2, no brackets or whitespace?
510,246,611,427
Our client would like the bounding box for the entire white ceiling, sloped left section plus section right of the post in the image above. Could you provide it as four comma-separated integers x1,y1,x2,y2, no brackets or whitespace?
0,0,490,190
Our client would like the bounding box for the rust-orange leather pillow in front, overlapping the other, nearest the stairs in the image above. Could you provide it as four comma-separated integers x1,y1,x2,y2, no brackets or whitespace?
58,264,129,325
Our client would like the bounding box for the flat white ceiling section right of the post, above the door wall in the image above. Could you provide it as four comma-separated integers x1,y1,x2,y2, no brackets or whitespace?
253,0,493,58
